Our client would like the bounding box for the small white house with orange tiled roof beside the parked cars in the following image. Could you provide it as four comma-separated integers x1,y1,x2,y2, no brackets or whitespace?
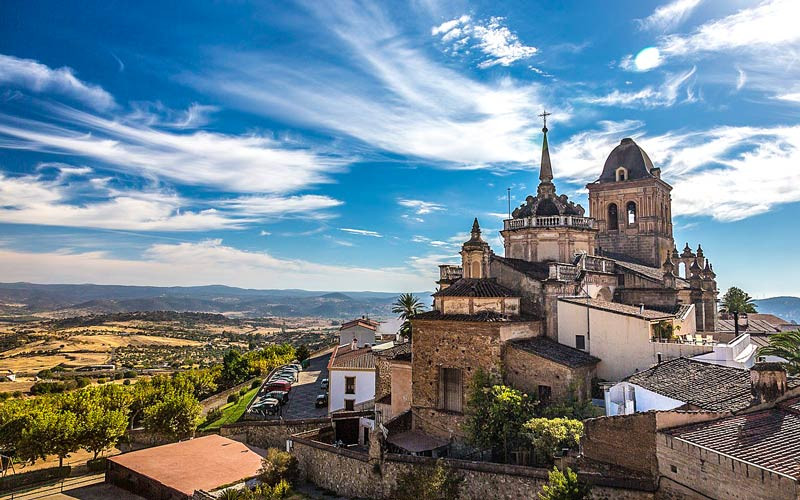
328,339,375,413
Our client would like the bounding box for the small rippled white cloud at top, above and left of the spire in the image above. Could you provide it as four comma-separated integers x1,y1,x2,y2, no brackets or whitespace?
431,15,539,68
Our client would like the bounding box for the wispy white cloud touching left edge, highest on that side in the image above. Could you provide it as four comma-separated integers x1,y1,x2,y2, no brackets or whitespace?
0,54,116,110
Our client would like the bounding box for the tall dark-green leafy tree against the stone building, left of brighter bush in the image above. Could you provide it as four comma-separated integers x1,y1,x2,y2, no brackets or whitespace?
464,371,535,462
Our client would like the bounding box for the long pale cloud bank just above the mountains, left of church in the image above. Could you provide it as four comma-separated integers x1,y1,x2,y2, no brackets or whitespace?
0,240,435,292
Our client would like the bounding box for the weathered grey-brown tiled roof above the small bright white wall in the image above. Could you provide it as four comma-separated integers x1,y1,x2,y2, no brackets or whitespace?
625,358,800,411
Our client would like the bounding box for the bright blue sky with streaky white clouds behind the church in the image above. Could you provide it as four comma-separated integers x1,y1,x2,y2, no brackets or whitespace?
0,0,800,298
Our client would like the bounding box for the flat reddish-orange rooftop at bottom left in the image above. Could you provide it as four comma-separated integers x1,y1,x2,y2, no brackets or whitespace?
108,435,266,496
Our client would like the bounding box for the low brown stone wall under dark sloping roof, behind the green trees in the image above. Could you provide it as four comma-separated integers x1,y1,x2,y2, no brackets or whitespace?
503,344,594,401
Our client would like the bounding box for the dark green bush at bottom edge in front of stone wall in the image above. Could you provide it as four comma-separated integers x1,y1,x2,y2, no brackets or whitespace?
392,461,461,500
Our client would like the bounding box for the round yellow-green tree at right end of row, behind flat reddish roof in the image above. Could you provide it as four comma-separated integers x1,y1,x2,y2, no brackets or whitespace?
144,392,202,438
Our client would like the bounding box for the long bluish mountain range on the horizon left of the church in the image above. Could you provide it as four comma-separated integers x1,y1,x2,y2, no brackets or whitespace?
0,283,431,319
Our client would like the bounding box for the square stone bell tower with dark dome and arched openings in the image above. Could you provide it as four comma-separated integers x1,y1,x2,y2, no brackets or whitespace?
586,138,675,268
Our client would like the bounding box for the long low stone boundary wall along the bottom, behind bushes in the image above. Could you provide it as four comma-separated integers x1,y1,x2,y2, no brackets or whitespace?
291,431,655,500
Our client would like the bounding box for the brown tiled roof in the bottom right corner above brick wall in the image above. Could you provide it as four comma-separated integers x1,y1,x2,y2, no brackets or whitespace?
664,398,800,479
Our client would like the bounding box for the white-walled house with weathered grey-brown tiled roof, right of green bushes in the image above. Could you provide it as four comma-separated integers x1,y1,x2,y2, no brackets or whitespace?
605,358,800,416
